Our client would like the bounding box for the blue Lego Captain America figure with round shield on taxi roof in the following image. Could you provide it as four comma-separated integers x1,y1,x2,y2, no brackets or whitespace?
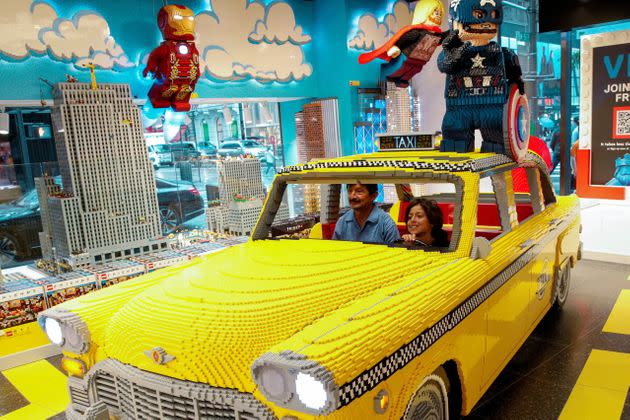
438,0,529,158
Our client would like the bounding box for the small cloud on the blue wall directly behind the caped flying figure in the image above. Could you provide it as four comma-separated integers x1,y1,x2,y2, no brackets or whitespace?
348,0,413,51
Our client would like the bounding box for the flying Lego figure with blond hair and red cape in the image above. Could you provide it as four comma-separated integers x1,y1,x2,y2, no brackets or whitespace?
359,0,445,88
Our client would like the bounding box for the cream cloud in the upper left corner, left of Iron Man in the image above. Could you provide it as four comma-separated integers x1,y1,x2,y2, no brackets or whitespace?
0,0,135,69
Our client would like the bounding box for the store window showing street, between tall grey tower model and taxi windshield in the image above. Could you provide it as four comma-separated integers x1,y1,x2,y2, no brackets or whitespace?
144,102,284,234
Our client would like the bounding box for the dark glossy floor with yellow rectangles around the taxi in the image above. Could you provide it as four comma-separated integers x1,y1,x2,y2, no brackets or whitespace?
0,261,630,420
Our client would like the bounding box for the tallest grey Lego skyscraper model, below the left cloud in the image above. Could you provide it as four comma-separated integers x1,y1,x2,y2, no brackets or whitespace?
36,83,167,267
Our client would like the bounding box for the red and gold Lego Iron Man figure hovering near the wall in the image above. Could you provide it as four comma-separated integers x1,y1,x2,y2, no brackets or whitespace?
142,4,199,111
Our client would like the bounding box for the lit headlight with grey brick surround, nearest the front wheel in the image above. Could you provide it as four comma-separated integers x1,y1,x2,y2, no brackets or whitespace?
252,352,339,415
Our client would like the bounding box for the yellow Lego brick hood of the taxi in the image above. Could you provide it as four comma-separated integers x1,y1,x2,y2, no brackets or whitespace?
68,240,454,392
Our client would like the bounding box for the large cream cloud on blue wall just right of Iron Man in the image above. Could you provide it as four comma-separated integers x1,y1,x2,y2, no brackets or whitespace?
196,0,313,82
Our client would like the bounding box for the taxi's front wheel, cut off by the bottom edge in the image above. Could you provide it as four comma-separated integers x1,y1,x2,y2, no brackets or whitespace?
402,368,449,420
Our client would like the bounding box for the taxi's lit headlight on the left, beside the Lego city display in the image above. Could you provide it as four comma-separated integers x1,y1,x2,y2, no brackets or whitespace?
38,308,90,354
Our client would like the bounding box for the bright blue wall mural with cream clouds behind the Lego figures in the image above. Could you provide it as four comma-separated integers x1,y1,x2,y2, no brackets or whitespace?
0,0,400,158
